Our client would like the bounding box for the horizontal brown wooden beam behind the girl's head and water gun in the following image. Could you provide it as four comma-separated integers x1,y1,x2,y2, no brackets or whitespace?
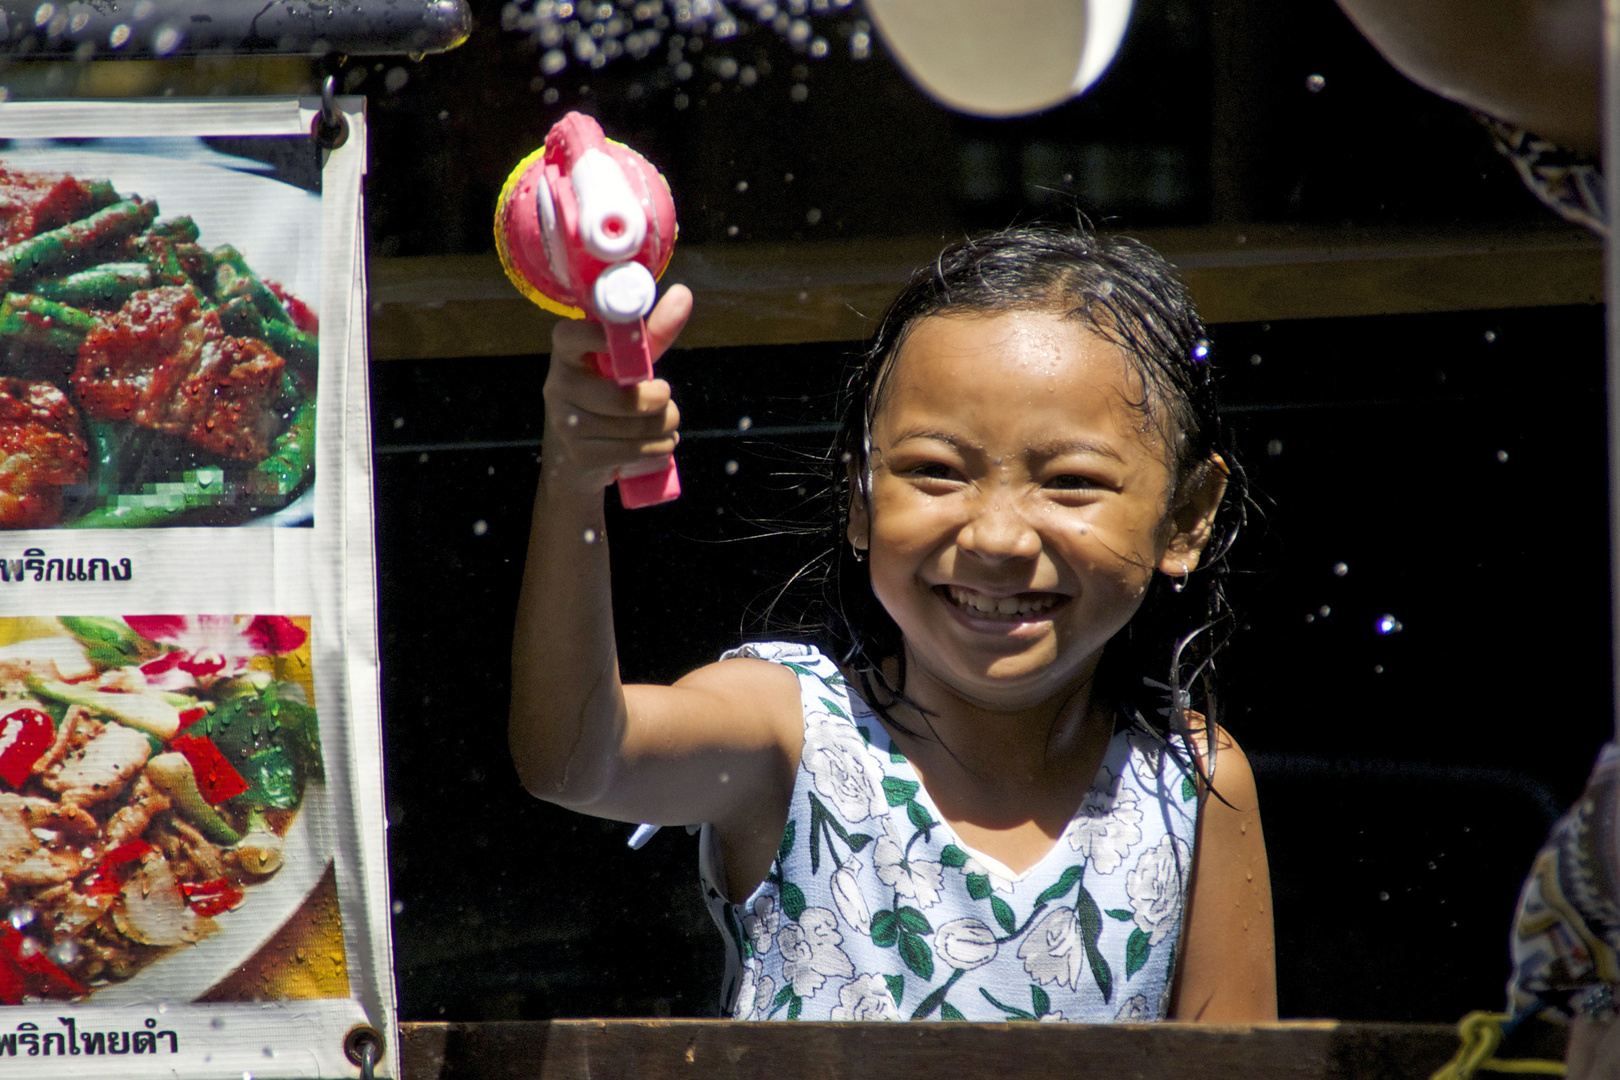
369,223,1602,359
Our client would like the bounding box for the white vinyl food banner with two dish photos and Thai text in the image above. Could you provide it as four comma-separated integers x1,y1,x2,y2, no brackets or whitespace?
0,99,397,1080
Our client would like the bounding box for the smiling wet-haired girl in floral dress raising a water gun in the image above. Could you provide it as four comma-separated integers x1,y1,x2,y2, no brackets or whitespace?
510,228,1277,1020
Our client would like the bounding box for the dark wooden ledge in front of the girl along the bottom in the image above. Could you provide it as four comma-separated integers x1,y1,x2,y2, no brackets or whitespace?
400,1020,1458,1080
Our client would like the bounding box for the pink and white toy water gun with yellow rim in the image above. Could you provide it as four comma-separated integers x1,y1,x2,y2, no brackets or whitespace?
496,112,680,508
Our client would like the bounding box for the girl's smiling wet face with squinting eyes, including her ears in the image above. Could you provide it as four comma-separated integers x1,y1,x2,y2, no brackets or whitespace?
849,311,1225,709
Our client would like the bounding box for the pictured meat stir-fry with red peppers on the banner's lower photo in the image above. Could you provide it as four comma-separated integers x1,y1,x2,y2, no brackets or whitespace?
0,615,322,1004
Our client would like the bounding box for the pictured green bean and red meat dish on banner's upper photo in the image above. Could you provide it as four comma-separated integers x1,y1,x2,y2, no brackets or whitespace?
0,167,318,528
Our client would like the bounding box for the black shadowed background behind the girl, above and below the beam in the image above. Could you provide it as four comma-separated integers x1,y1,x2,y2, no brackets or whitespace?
281,0,1610,1022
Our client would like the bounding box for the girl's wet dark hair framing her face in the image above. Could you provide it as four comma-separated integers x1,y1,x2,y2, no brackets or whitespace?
823,223,1247,748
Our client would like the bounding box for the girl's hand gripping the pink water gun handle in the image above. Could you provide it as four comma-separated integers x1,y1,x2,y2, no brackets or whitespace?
539,285,692,494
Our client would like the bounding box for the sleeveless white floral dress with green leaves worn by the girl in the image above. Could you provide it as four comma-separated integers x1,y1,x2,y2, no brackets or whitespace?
701,643,1197,1022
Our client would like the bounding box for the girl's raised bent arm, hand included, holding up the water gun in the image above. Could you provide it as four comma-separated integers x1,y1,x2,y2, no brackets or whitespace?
509,285,802,854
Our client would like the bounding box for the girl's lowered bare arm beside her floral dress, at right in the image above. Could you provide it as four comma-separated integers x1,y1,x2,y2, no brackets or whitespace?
1170,725,1277,1023
